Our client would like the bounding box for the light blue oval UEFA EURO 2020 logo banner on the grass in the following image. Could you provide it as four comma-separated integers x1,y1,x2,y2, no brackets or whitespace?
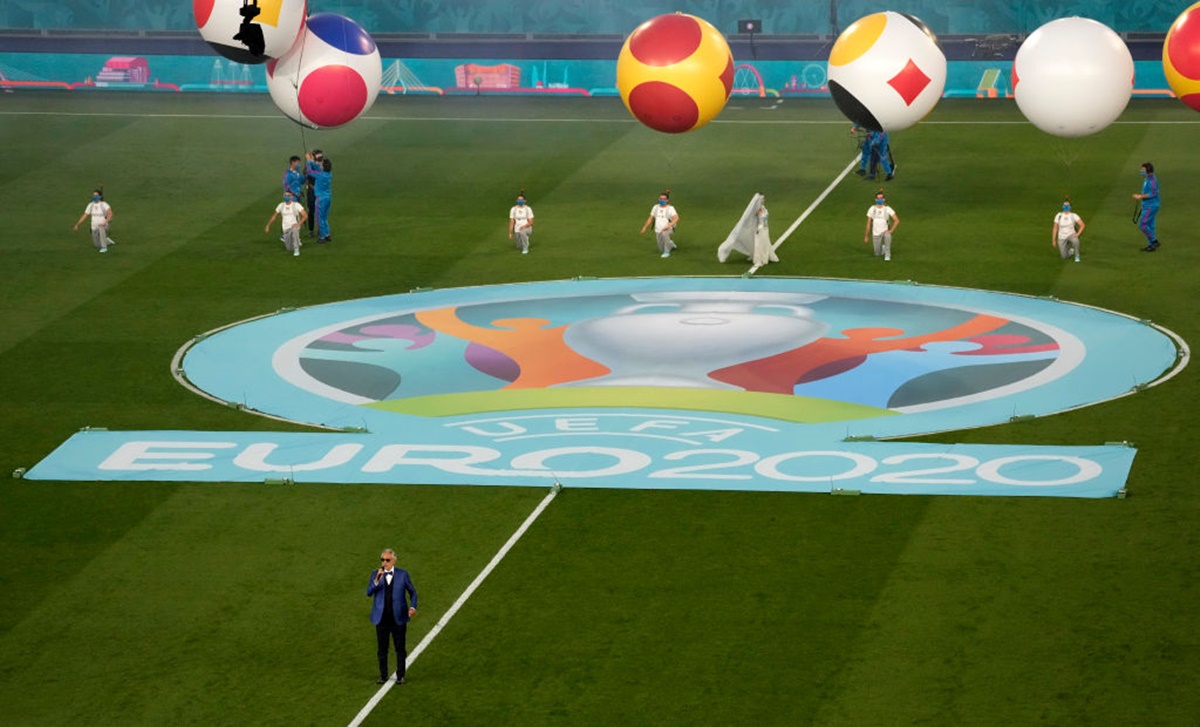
28,278,1182,497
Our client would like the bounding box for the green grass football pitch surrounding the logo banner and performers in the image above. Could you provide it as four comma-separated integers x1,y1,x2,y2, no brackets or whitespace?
0,92,1200,727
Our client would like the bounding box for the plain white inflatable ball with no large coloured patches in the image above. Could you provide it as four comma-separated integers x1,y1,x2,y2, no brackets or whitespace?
1013,18,1134,138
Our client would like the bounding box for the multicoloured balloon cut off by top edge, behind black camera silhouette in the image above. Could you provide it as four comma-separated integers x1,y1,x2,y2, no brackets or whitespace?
192,0,308,64
